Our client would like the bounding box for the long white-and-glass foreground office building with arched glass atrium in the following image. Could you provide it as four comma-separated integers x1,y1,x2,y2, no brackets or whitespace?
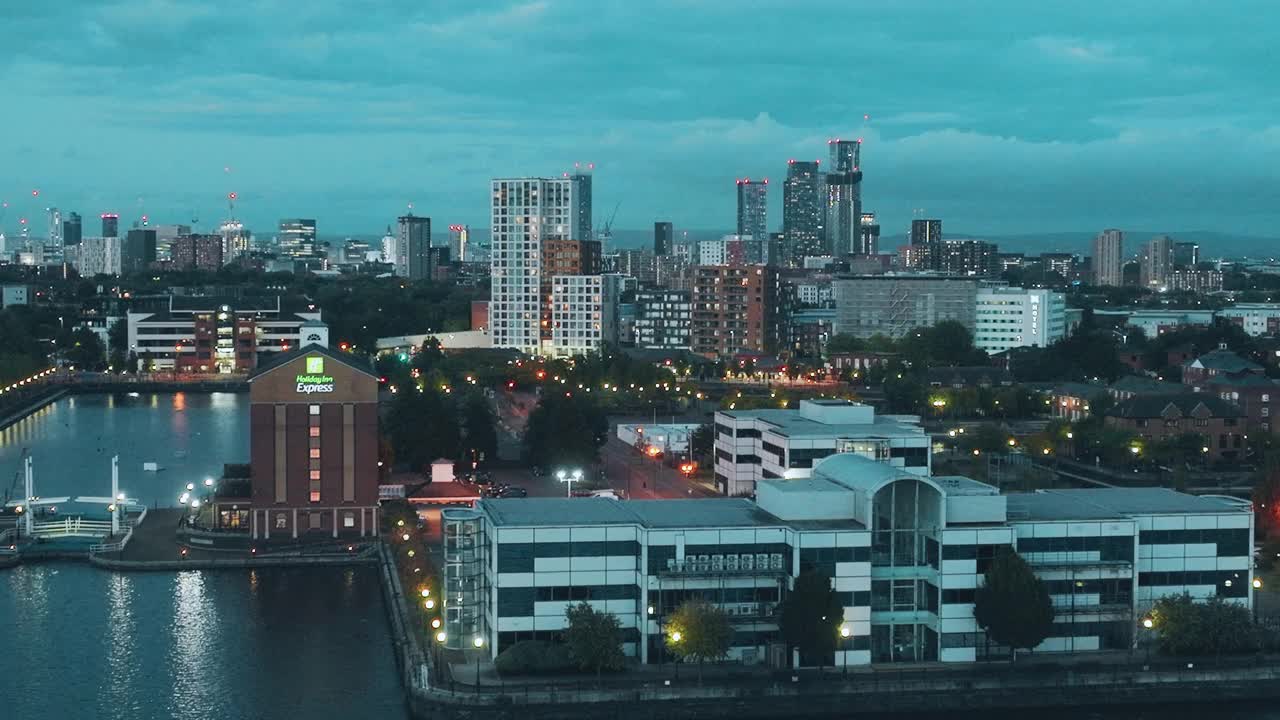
443,452,1253,666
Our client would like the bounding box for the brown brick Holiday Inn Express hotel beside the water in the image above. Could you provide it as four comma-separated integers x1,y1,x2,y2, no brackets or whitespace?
250,345,378,539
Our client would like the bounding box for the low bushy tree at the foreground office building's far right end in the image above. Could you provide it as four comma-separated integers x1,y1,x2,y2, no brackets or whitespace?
1149,591,1258,656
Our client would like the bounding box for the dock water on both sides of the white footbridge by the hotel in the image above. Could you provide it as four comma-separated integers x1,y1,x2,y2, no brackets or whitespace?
0,393,408,720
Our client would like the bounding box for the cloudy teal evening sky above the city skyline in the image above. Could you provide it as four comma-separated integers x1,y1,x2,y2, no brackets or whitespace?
0,0,1280,237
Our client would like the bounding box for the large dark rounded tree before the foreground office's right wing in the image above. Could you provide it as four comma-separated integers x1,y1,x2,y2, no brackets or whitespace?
973,546,1053,659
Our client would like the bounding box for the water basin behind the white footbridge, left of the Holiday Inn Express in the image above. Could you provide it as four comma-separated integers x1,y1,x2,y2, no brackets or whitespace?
0,392,248,506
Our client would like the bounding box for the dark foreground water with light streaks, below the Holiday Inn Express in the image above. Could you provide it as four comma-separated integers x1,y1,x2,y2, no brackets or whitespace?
0,564,407,720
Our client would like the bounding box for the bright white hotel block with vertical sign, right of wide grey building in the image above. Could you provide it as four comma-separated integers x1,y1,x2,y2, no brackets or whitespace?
973,287,1066,355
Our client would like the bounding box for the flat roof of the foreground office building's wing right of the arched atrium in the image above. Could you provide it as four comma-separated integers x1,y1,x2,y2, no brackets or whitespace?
1006,488,1249,523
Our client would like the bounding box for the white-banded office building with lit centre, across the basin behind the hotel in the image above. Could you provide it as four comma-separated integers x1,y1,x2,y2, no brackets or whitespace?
125,294,329,373
